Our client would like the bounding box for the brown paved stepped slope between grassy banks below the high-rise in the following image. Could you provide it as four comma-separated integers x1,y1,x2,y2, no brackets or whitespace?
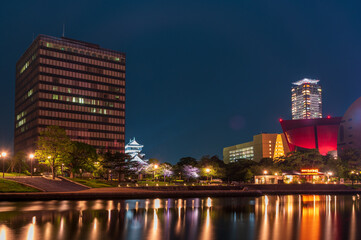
6,176,88,192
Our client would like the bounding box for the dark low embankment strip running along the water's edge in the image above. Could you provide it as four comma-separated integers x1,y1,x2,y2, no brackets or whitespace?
0,190,361,201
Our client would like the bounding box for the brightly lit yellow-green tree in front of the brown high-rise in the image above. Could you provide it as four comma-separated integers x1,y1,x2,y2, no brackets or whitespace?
35,126,71,179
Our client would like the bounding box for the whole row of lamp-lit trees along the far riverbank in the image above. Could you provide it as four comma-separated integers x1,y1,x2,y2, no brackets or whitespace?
7,126,361,182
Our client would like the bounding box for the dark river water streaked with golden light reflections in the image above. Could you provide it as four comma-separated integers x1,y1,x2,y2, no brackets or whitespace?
0,195,361,240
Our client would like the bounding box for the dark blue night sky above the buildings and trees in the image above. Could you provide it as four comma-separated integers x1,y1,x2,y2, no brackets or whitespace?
0,0,361,163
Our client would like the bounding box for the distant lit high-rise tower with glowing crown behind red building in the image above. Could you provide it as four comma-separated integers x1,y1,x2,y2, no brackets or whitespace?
292,78,322,119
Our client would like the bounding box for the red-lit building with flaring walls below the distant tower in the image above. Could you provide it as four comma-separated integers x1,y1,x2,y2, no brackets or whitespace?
280,117,341,155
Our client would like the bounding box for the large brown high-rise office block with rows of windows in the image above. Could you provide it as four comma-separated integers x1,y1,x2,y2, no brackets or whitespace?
14,35,125,152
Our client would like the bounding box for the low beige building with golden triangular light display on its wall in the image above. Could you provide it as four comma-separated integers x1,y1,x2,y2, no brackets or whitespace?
223,133,289,164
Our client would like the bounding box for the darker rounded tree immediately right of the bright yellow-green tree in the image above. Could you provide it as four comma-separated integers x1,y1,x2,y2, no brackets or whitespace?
64,141,97,178
